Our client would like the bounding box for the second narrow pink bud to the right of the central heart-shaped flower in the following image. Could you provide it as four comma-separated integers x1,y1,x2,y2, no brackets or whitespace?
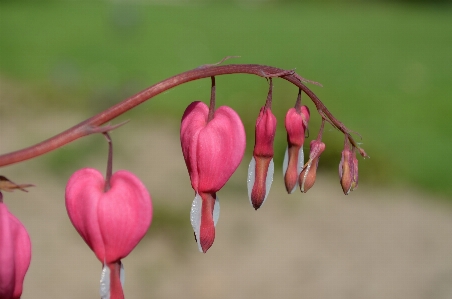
283,106,309,193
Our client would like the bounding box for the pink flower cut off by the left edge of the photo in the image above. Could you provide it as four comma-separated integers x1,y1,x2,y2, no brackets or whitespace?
0,192,31,299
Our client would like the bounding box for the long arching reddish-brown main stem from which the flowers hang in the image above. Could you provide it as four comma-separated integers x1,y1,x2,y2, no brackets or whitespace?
0,64,356,166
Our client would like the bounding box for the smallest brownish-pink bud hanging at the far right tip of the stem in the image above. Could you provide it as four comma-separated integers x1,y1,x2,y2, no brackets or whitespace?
339,140,358,195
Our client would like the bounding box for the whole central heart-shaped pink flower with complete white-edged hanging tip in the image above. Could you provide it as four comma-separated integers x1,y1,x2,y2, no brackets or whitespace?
180,102,246,252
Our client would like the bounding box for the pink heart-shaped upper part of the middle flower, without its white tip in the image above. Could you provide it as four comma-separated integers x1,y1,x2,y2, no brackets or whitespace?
181,102,246,193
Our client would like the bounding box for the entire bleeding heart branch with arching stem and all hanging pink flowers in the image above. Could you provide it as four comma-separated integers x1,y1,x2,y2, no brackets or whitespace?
0,63,367,299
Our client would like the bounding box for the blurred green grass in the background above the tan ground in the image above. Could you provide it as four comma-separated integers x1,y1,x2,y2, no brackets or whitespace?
0,1,452,196
